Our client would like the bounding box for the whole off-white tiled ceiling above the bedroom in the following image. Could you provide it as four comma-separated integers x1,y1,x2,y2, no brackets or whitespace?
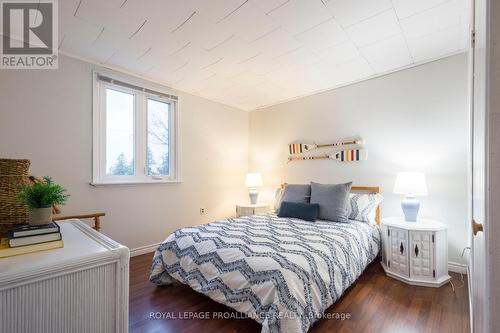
59,0,469,110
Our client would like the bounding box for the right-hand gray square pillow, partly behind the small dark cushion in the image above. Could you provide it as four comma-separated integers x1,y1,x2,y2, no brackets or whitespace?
311,182,352,223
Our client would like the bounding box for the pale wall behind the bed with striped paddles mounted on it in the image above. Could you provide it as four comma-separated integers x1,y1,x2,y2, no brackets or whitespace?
249,54,468,263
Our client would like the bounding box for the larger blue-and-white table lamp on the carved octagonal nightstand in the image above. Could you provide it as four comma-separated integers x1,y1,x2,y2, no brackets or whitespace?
394,172,427,222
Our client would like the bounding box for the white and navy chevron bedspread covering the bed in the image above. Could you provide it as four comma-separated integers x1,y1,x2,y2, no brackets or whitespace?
150,214,380,332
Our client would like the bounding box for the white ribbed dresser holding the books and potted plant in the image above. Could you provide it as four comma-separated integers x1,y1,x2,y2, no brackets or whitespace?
0,220,130,333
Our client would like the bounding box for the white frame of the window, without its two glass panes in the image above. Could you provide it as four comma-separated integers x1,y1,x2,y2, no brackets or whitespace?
91,70,181,185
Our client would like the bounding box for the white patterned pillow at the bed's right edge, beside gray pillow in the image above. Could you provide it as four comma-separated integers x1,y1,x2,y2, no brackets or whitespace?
347,193,384,224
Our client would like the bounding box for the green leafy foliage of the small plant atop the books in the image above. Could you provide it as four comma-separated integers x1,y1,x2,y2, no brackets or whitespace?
18,177,69,209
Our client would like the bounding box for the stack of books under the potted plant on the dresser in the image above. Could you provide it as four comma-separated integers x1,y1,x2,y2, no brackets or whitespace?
0,222,63,258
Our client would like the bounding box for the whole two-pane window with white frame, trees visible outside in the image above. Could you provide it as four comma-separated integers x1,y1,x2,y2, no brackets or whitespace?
92,73,180,185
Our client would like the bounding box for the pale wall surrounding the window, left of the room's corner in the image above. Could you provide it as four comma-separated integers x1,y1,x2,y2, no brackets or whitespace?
0,56,248,252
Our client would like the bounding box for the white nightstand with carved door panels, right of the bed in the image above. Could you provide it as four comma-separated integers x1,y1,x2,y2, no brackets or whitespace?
381,217,450,287
